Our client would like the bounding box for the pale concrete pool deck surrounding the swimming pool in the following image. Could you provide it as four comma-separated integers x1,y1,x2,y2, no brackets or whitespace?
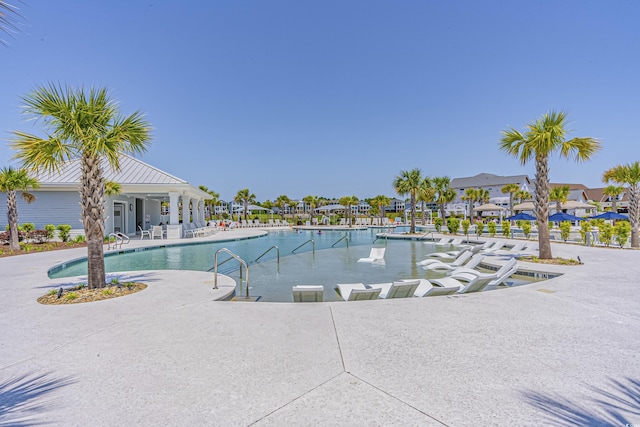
0,229,640,426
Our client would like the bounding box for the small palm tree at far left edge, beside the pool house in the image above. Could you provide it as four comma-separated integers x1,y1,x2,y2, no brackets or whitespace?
0,166,40,251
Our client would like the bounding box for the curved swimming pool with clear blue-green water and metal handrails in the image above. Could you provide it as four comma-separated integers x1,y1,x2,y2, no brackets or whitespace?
49,228,544,302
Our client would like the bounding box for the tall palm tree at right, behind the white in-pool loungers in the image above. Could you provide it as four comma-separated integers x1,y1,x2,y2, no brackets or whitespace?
500,111,600,259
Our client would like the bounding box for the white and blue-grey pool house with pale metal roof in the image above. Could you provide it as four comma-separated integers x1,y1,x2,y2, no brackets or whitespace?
0,154,211,236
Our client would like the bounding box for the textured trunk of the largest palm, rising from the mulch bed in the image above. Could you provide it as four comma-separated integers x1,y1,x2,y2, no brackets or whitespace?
80,154,106,289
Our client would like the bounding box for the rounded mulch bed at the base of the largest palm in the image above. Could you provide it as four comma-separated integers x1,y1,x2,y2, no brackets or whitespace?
38,282,147,305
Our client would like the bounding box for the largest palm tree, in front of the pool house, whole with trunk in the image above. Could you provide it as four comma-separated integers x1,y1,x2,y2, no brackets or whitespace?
12,84,151,288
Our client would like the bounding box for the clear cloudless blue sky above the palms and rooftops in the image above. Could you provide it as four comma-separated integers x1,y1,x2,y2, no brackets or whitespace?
0,0,640,201
